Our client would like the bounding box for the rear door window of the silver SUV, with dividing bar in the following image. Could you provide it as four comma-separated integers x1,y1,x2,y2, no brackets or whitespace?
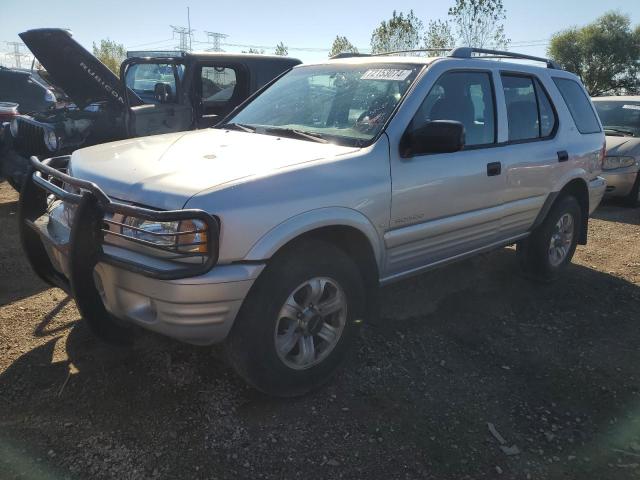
501,74,557,142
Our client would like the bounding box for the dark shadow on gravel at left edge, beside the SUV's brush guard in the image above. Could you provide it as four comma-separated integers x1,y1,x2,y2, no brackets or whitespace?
0,202,49,305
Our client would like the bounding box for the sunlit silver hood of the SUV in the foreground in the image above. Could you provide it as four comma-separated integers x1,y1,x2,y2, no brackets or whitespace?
71,129,358,210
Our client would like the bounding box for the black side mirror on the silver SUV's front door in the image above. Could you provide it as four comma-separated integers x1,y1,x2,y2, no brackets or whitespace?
400,120,464,158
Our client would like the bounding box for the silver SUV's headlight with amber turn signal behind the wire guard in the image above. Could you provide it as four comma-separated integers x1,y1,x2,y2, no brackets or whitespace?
122,217,207,253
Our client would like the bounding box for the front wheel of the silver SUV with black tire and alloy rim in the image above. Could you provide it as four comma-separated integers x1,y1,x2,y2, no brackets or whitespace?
226,240,365,397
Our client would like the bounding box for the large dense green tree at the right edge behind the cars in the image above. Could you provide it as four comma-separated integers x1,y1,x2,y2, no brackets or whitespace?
548,12,640,96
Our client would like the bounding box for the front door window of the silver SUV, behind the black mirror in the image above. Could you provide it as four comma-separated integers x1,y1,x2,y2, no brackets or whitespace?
411,71,496,146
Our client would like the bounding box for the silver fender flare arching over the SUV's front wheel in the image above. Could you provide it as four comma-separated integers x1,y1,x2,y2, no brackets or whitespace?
244,207,384,269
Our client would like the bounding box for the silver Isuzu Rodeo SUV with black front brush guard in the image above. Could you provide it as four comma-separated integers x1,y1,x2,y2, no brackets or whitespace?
20,48,605,395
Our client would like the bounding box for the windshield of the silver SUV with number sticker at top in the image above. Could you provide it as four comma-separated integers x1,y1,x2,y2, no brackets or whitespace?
227,64,421,146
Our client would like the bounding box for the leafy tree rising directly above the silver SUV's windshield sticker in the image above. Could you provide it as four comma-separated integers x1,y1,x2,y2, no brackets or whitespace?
371,10,424,53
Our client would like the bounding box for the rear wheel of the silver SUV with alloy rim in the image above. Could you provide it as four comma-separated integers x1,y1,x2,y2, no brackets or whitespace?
517,195,582,282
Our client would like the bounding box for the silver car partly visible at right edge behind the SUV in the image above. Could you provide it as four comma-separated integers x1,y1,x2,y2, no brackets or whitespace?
593,96,640,207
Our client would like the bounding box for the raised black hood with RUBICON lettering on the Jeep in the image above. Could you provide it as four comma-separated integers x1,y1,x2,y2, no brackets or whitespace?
20,28,125,108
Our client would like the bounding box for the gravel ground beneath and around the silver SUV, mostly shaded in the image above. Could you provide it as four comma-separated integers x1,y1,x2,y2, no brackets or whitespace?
0,184,640,480
